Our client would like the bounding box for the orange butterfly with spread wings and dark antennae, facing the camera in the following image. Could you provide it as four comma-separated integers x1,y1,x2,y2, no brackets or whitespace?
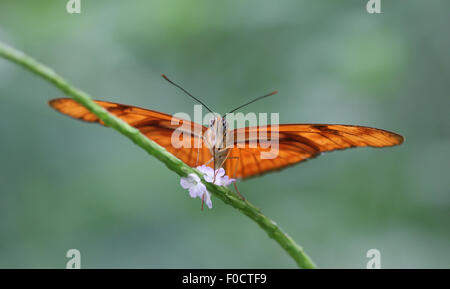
49,74,403,189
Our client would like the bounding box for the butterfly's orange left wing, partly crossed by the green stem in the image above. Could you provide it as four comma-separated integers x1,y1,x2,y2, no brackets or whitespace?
49,98,211,166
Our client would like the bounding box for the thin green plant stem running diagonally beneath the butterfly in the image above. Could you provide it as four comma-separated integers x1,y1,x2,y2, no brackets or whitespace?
0,42,315,268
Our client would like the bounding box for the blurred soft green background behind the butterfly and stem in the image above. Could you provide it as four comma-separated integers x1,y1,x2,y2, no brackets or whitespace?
0,0,450,268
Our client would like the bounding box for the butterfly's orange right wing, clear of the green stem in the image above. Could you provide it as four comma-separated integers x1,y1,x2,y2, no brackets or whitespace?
224,124,403,179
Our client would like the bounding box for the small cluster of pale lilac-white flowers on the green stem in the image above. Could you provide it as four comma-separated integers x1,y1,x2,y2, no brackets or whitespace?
180,165,236,209
